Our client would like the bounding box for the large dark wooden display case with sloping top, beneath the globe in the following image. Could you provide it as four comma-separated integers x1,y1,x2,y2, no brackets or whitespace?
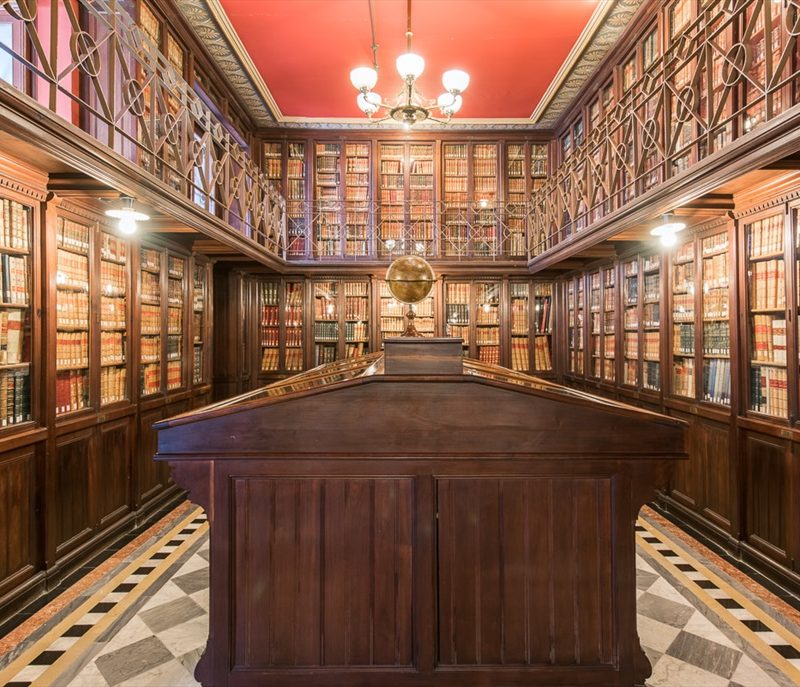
156,339,685,687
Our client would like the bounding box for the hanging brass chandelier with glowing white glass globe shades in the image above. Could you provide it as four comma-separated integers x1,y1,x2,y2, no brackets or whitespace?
350,0,469,129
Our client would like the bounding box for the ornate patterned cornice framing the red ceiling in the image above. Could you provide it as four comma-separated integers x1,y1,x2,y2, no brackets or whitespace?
175,0,643,130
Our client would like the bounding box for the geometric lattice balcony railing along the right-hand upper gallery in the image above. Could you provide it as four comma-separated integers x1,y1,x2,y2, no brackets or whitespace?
528,0,800,260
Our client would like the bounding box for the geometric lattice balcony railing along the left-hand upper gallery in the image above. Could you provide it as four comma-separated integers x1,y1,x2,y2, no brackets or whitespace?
0,0,286,258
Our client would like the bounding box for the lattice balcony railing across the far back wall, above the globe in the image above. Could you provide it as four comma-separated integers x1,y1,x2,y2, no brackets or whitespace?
286,200,529,264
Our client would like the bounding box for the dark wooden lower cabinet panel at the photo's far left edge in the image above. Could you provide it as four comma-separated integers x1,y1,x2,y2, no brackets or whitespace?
0,445,43,606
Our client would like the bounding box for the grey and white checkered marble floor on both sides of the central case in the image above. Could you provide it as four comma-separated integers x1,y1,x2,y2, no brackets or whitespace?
0,513,800,687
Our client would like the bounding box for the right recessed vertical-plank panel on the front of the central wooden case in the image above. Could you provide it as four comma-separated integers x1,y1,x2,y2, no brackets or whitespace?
437,478,615,666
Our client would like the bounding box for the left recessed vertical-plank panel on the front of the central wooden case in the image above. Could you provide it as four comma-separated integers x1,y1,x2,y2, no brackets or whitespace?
231,477,413,669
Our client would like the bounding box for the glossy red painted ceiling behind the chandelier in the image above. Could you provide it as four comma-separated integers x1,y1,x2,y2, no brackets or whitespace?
221,0,598,118
